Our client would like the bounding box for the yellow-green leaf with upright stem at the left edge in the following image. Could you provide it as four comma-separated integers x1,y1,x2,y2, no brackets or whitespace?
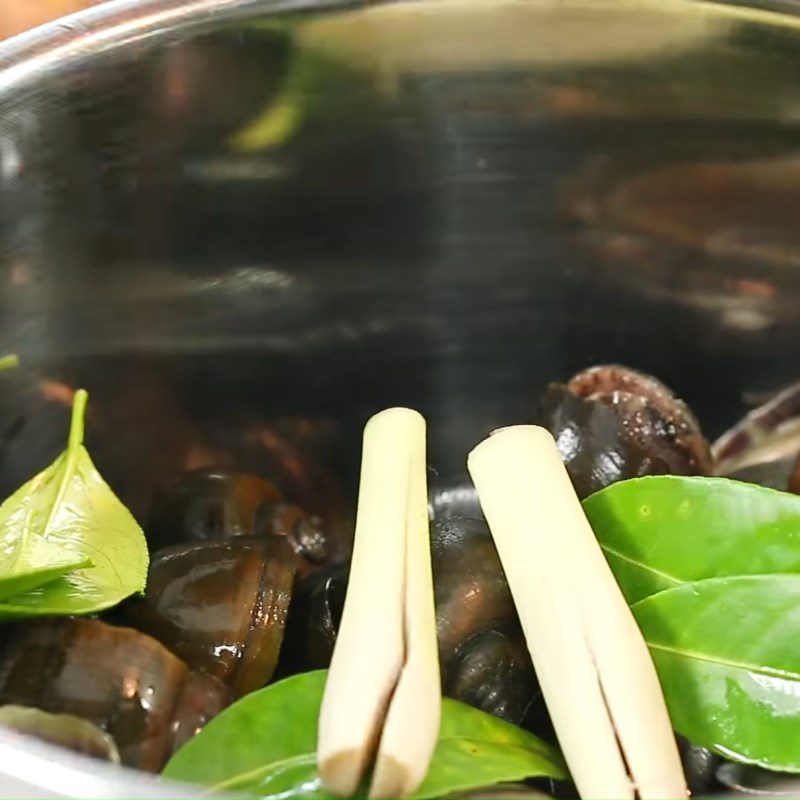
0,390,148,619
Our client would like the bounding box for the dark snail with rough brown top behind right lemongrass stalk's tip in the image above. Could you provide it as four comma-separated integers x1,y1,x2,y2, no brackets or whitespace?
538,365,711,498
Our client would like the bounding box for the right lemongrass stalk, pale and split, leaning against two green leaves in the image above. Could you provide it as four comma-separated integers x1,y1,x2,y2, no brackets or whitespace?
468,425,687,800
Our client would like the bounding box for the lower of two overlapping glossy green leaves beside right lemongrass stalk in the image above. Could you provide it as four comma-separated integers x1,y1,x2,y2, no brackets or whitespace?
633,575,800,772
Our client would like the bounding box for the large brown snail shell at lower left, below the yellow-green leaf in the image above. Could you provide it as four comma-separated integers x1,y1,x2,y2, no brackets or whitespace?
0,619,227,771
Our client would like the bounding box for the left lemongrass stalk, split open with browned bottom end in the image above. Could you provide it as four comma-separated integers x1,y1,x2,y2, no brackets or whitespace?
317,408,441,797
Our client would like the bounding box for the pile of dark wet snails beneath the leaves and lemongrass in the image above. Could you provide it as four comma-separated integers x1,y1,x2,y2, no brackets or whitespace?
0,365,800,791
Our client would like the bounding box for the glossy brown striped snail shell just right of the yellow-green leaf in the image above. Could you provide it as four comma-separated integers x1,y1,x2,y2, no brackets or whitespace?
127,537,297,695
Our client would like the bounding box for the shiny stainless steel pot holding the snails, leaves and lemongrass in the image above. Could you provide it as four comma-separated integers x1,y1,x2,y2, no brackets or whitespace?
0,0,800,797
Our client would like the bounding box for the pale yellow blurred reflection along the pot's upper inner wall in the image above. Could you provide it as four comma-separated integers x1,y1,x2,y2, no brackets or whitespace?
301,0,720,73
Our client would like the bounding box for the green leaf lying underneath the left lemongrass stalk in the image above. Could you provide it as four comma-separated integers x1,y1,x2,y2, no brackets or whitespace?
163,670,565,800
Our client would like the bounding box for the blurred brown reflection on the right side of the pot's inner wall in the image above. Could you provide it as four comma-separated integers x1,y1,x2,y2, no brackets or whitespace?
562,153,800,334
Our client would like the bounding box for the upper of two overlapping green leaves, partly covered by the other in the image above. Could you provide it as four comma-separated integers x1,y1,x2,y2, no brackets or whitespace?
583,476,800,603
